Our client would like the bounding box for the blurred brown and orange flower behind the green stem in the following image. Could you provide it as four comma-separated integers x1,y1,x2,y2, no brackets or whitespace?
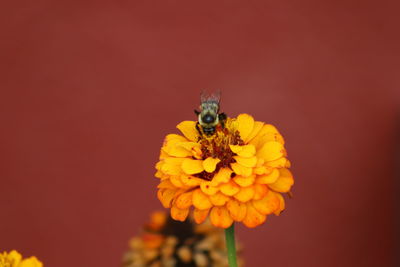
123,212,243,267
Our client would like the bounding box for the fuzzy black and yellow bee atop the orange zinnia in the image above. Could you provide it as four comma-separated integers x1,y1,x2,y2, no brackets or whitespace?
194,91,227,136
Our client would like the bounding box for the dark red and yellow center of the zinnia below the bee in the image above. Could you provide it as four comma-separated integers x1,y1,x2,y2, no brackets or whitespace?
195,118,244,181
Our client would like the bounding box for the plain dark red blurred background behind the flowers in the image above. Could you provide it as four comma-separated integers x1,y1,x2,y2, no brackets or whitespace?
0,0,400,267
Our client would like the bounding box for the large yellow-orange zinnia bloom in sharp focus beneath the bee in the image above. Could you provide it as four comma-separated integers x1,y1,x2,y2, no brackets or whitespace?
155,114,294,228
